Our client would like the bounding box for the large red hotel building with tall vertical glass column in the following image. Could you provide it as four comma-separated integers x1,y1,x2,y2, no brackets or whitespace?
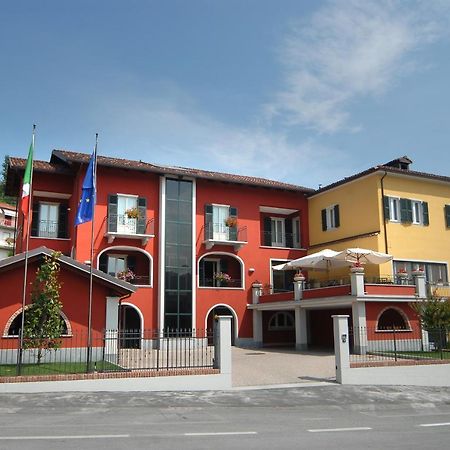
0,150,313,345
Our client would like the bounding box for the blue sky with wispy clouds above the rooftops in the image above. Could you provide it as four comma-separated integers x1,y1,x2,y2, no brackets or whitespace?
0,0,450,188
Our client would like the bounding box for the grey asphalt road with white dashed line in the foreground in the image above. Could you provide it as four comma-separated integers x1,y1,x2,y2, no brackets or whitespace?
0,385,450,450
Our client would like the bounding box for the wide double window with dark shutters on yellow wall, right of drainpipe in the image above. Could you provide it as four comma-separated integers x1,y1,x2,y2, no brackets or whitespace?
383,196,429,225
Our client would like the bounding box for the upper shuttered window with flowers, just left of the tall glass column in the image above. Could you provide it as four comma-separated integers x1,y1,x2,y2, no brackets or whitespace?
108,194,147,235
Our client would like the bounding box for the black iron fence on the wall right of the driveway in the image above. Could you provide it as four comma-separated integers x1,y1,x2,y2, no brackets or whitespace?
349,326,450,365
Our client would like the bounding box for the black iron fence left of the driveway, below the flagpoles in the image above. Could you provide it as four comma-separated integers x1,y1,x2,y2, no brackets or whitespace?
0,329,216,377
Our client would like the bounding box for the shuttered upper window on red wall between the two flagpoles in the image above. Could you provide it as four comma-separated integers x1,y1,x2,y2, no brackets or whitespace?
31,201,68,239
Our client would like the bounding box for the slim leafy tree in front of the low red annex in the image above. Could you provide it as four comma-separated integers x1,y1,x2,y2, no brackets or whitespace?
23,252,64,364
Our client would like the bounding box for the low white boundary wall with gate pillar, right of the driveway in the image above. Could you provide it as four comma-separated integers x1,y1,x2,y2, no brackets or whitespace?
333,315,450,387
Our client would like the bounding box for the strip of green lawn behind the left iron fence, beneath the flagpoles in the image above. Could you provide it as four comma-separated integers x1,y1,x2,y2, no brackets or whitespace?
0,361,121,377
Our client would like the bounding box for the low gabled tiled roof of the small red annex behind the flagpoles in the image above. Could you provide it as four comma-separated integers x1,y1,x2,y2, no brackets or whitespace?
0,246,137,295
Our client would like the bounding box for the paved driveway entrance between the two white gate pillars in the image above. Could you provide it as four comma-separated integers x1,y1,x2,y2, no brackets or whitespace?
232,347,336,387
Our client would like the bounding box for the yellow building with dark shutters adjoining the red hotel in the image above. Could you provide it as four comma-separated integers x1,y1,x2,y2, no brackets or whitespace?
308,156,450,284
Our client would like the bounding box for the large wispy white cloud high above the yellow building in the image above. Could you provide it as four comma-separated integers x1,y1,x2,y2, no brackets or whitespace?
266,0,450,133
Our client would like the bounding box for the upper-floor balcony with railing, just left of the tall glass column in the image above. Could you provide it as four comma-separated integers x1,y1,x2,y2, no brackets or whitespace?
104,214,155,245
